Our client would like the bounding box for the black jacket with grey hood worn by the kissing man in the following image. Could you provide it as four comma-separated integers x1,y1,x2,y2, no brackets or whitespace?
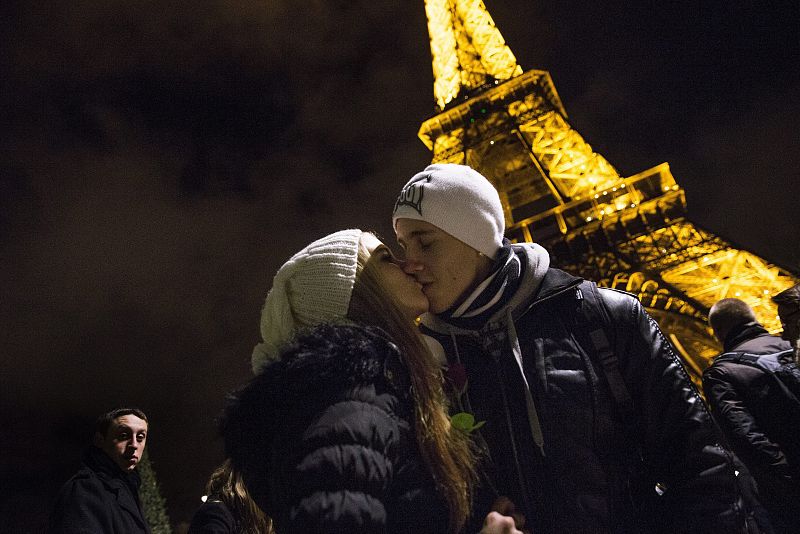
423,244,742,534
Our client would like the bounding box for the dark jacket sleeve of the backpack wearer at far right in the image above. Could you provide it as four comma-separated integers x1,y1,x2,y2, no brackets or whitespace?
703,365,792,482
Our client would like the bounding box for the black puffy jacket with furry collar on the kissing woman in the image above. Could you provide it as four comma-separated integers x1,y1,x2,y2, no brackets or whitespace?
222,325,448,534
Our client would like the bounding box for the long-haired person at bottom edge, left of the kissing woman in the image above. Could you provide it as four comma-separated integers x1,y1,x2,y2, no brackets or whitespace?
188,460,274,534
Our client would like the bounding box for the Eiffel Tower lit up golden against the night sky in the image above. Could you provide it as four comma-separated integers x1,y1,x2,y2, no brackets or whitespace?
419,0,797,385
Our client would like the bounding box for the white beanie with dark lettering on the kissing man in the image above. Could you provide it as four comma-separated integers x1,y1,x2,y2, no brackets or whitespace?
392,163,505,259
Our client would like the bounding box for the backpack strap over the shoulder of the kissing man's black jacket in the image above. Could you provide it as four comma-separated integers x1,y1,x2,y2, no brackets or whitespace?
575,282,635,415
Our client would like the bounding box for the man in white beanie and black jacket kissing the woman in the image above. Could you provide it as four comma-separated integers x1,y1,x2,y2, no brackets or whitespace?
393,164,747,534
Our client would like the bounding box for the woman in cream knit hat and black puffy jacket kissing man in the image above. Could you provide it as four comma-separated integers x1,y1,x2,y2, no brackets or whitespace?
221,230,476,534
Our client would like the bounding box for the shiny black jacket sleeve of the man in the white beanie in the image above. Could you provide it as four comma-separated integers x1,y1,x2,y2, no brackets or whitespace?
601,290,743,533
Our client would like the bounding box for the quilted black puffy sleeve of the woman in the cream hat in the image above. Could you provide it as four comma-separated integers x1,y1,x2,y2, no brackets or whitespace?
276,385,402,533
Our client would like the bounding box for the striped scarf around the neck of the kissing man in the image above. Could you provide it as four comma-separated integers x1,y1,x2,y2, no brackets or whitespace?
437,243,523,330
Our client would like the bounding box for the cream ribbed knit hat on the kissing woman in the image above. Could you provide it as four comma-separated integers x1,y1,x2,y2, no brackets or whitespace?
251,229,362,373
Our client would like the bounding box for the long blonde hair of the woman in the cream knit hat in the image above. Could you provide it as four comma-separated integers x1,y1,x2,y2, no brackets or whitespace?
347,236,476,532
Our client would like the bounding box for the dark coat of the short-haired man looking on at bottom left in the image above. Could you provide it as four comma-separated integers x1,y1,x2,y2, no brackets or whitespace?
49,447,150,534
